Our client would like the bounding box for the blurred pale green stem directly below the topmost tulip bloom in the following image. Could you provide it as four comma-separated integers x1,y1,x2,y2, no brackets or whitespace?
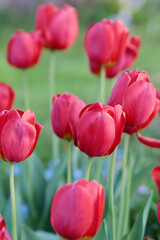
48,51,55,111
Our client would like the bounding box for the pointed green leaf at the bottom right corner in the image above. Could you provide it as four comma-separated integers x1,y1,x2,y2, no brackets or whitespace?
122,193,153,240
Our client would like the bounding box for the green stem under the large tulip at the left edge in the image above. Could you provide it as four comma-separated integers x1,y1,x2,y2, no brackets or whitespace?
10,164,17,240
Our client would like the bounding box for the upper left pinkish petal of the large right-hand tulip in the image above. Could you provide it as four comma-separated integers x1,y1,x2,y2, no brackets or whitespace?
106,72,131,106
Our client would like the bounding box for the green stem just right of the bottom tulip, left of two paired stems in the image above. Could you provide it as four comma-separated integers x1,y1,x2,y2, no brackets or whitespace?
108,149,117,240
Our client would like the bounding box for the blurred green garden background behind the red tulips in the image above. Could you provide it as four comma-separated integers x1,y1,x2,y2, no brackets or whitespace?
0,0,160,239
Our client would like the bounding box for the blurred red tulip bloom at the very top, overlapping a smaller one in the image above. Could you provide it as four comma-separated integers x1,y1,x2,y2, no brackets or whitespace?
36,4,79,50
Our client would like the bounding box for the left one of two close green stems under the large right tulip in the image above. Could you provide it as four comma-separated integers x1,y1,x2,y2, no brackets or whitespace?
117,134,129,240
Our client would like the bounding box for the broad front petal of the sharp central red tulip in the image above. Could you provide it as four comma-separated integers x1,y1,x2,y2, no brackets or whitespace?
77,106,115,157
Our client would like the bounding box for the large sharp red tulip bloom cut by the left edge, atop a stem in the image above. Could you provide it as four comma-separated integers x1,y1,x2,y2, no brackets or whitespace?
0,109,43,162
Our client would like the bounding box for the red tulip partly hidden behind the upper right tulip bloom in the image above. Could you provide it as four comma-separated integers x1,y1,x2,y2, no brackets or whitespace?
89,36,141,78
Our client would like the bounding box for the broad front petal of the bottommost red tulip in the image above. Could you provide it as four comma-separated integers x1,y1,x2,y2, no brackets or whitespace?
50,184,93,239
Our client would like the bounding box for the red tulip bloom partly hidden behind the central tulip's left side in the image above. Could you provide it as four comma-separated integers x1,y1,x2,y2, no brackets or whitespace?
51,93,85,140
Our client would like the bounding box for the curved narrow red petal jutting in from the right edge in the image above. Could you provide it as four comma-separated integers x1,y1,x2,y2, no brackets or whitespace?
137,133,160,148
